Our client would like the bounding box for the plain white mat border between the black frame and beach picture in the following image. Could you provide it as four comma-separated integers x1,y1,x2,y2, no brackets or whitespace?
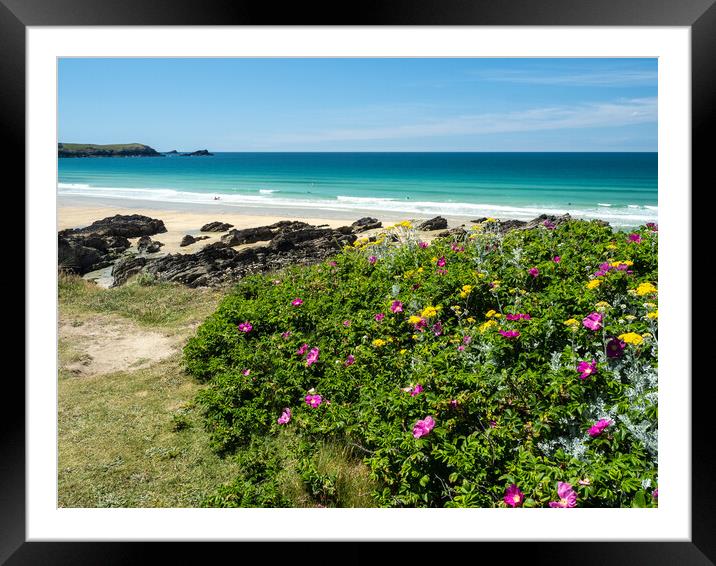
26,27,691,541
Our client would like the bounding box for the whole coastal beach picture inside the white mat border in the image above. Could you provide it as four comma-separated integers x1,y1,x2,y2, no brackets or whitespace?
56,56,666,515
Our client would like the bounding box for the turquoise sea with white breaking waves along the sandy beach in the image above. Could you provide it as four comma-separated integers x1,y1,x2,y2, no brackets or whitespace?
57,153,658,227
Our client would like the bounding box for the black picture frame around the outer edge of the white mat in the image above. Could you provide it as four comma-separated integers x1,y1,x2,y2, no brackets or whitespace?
5,0,716,565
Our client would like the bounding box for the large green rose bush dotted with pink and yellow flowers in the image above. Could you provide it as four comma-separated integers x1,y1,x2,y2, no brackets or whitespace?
185,219,658,507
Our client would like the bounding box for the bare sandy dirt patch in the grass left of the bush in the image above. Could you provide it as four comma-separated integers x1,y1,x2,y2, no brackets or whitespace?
59,315,183,376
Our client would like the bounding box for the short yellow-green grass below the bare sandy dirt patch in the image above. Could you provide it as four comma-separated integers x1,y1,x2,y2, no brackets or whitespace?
58,358,246,507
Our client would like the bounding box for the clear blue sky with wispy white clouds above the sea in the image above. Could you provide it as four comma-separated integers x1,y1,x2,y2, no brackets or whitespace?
58,58,657,151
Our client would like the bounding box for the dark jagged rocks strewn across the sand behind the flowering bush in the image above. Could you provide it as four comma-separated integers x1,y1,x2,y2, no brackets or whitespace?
58,214,576,288
